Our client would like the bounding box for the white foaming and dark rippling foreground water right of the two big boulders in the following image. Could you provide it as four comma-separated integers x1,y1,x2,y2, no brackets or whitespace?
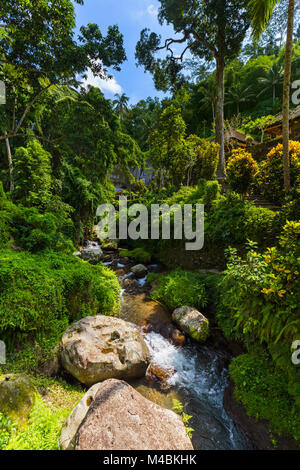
145,332,248,449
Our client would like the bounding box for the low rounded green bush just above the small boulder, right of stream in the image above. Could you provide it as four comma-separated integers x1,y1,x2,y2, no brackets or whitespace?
150,269,207,310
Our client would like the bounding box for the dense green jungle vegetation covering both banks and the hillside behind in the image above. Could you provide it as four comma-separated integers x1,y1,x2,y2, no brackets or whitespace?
0,0,300,449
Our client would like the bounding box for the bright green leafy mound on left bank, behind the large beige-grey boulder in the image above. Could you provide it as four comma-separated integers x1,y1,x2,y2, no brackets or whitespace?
0,250,119,344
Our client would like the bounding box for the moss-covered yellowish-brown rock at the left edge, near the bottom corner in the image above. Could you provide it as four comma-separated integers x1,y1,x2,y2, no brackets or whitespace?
0,374,35,427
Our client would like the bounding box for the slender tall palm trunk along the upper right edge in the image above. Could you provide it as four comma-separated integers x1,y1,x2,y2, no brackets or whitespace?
282,0,295,194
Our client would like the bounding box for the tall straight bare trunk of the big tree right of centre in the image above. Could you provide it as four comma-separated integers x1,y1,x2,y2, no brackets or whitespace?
216,57,226,179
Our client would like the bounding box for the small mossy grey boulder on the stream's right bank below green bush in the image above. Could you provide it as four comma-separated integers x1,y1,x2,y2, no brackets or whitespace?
172,305,209,342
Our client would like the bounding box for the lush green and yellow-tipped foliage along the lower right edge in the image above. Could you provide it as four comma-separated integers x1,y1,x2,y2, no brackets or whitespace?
217,222,300,439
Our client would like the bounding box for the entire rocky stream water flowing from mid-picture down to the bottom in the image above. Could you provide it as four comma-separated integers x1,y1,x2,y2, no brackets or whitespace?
88,242,252,450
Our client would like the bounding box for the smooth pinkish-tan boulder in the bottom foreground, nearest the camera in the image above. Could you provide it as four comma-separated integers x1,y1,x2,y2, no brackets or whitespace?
75,380,193,450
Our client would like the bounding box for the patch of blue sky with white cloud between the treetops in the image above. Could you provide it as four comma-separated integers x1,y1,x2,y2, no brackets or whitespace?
75,0,172,104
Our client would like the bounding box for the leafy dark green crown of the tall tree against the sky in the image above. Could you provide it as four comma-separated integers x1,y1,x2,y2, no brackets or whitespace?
136,0,249,91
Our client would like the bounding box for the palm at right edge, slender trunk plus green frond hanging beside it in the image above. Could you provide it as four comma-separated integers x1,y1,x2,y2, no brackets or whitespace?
248,0,295,193
